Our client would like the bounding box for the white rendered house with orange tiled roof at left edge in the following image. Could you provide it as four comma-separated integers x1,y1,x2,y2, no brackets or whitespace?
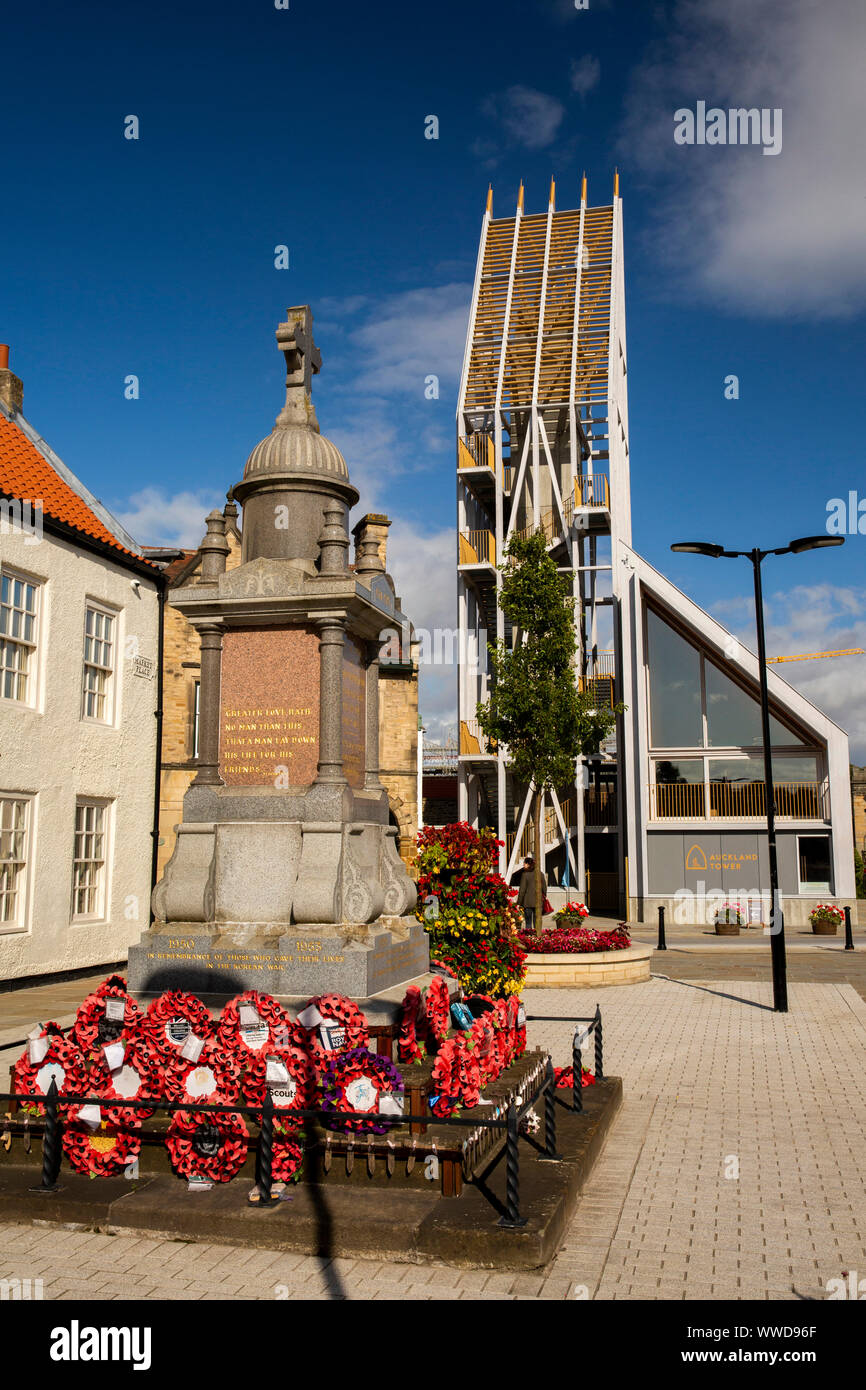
0,349,161,998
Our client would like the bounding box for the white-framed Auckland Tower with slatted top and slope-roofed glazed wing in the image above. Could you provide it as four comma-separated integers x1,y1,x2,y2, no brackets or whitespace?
457,179,856,926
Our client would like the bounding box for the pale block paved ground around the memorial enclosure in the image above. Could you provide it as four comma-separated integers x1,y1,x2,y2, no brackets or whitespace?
0,952,866,1300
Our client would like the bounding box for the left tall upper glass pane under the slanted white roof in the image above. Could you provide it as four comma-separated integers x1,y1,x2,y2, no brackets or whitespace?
646,610,703,748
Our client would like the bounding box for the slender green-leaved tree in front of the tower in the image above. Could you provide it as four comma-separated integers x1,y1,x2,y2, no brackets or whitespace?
478,531,626,931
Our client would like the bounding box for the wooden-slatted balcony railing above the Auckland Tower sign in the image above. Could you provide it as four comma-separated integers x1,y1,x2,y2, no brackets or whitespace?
649,781,828,820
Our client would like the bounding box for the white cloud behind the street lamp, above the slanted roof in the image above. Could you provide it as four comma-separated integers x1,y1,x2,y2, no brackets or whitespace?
710,584,866,765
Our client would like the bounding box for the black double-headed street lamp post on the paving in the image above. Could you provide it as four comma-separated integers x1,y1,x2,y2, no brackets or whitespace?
671,535,844,1013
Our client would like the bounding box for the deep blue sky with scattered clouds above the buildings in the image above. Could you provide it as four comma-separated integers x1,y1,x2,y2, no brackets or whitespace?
0,0,866,762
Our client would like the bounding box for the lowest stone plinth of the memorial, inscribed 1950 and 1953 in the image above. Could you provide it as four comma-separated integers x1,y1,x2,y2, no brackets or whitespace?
128,917,430,998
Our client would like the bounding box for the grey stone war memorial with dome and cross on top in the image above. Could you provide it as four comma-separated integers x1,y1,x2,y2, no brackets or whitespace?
129,306,428,999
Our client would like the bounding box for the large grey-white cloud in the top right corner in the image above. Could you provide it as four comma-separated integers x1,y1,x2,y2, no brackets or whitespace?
620,0,866,318
